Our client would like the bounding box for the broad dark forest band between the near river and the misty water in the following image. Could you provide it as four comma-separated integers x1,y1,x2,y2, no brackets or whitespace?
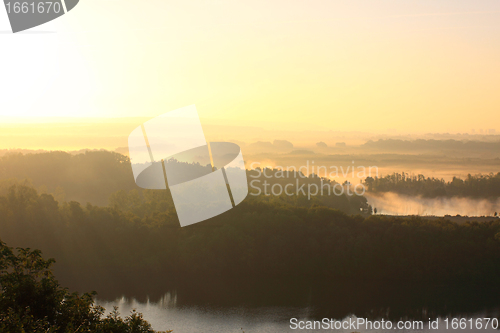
0,186,500,298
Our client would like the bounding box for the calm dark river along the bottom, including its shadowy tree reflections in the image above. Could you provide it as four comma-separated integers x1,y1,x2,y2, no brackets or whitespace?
97,283,500,333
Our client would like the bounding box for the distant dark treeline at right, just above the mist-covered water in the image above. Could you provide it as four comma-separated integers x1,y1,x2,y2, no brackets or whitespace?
364,172,500,198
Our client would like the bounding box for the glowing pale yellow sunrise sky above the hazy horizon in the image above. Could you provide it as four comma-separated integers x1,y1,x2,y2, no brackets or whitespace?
0,0,500,135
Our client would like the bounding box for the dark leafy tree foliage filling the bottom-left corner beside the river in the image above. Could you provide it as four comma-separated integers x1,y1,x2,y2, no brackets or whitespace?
0,241,171,333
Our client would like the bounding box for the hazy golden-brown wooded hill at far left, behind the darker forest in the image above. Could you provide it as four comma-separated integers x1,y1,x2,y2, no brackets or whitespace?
0,151,136,206
